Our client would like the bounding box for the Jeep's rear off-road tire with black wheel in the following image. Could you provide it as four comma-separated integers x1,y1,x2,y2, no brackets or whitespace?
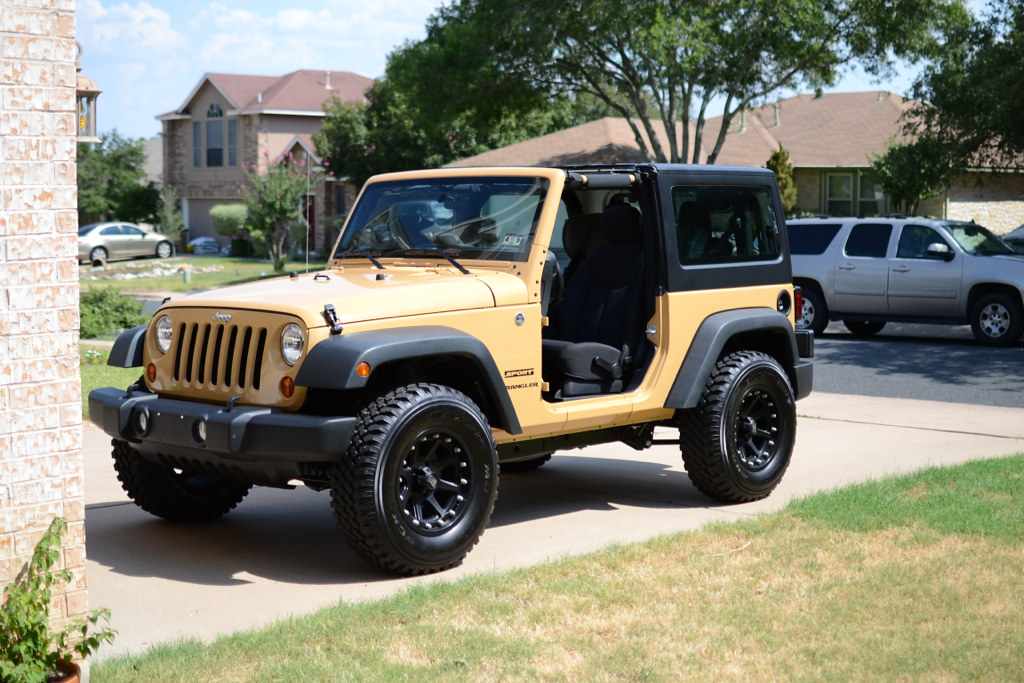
679,351,797,503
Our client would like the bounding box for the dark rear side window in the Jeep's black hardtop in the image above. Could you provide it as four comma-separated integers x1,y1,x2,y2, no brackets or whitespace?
672,185,779,265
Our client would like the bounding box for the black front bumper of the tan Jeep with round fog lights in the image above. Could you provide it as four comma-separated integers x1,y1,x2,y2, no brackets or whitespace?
89,387,356,485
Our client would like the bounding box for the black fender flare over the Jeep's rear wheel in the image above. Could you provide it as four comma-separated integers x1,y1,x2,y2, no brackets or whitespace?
665,308,811,410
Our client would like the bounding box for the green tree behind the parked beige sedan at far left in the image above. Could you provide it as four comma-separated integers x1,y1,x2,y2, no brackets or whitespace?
78,130,160,225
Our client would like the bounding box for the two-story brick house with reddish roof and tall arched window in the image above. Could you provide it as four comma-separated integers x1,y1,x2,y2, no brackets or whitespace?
157,70,373,251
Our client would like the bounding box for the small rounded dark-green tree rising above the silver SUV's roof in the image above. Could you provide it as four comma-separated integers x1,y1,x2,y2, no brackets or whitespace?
870,138,953,216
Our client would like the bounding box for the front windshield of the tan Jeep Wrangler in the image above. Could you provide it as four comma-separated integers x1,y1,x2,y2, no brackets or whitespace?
334,177,548,261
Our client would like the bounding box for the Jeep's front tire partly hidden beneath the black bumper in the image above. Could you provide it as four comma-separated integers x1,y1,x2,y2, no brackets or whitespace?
113,439,252,522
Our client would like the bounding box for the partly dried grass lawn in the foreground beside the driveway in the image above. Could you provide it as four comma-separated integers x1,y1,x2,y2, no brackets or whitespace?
92,456,1024,683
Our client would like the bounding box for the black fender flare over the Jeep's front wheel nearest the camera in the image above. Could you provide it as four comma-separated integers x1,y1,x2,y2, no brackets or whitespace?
295,326,522,434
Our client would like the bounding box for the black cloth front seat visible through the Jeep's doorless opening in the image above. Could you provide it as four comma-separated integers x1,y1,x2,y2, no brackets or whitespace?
543,205,645,398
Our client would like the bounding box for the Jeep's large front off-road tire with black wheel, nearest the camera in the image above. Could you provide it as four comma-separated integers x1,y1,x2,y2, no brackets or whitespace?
331,384,499,575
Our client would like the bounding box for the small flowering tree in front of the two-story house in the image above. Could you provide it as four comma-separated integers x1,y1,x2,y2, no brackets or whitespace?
239,153,323,272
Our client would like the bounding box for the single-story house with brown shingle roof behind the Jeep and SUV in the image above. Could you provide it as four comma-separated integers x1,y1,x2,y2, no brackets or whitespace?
455,92,1024,233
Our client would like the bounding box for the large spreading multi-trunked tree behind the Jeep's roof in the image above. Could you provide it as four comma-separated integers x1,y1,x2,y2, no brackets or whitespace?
407,0,967,163
